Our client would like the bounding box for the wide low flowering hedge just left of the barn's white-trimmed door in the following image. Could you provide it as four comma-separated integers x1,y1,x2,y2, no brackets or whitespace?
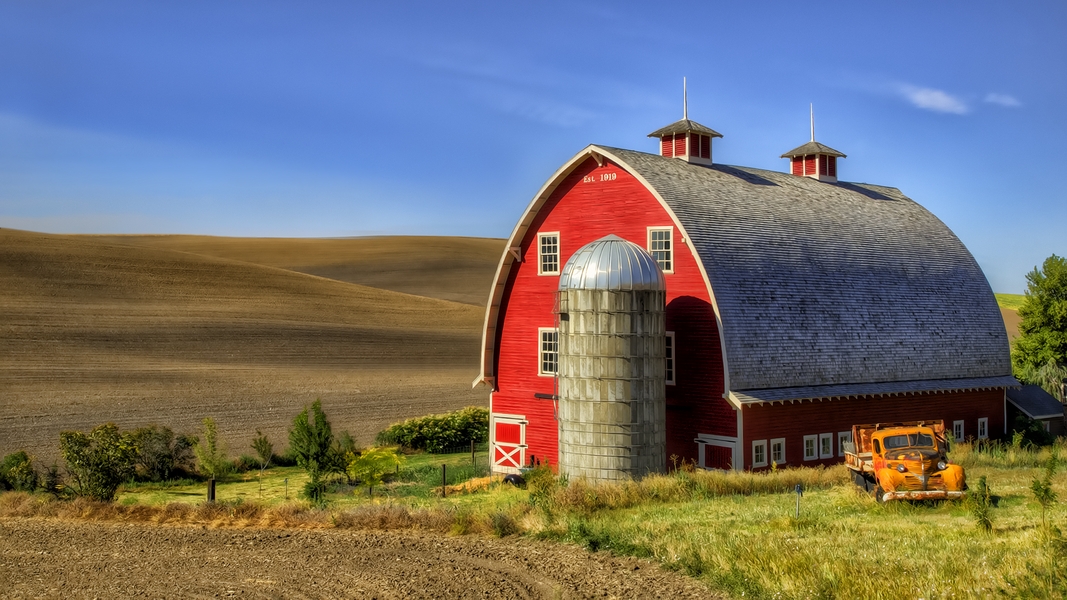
376,407,489,453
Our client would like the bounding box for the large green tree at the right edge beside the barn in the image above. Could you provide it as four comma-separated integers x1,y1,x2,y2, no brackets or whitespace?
1012,254,1067,397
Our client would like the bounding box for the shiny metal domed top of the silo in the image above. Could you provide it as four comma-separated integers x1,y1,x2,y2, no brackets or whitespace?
559,235,667,291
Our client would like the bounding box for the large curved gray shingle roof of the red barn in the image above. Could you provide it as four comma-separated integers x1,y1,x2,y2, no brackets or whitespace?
590,146,1012,395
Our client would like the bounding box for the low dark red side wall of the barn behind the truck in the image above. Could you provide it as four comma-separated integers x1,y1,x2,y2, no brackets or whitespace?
744,390,1004,470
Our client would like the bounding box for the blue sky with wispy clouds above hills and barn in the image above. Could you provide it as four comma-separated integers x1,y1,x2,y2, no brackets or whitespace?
0,0,1067,293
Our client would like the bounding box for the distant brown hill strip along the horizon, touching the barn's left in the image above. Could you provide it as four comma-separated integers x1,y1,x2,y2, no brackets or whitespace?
85,235,505,306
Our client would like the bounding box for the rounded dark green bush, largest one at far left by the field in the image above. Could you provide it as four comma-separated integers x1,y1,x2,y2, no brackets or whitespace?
60,423,137,502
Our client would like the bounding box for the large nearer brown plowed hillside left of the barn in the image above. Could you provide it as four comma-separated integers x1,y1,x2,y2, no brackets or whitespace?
0,230,485,459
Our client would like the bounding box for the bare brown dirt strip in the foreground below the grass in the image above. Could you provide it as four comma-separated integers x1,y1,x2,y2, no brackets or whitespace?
0,519,713,598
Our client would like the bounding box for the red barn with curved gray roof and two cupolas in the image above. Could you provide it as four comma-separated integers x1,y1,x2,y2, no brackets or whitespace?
475,112,1018,472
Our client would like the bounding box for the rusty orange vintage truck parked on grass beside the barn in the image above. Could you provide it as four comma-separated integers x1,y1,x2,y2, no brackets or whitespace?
844,421,967,502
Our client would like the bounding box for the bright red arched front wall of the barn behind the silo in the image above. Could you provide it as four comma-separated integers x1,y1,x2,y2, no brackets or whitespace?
492,158,736,471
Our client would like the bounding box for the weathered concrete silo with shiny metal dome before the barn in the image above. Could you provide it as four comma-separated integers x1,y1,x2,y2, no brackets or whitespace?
558,235,667,480
